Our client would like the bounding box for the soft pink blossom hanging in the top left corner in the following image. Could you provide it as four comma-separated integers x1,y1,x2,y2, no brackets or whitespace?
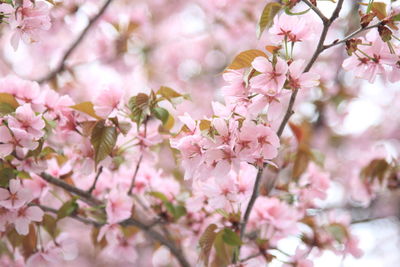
10,0,51,49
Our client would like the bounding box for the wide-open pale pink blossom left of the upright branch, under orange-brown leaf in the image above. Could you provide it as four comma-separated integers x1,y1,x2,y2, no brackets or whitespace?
250,57,288,96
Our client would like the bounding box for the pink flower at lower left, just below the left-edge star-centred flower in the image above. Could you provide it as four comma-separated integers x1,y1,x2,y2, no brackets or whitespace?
14,206,44,235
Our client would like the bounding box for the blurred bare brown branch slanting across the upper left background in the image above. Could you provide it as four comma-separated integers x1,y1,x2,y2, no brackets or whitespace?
37,0,113,83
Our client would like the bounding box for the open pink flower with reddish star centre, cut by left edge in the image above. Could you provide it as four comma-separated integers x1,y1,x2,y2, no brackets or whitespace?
0,179,32,209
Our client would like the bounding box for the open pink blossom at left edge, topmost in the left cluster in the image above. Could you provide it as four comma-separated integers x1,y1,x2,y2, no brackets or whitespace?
8,104,45,138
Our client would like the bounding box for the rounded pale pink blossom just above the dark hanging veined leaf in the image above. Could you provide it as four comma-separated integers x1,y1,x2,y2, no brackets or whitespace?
94,87,124,118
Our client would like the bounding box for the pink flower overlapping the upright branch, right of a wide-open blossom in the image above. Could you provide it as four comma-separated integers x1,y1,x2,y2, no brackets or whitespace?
288,59,319,89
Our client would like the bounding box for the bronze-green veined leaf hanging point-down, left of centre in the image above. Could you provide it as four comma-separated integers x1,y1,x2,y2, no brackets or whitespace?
90,120,118,166
